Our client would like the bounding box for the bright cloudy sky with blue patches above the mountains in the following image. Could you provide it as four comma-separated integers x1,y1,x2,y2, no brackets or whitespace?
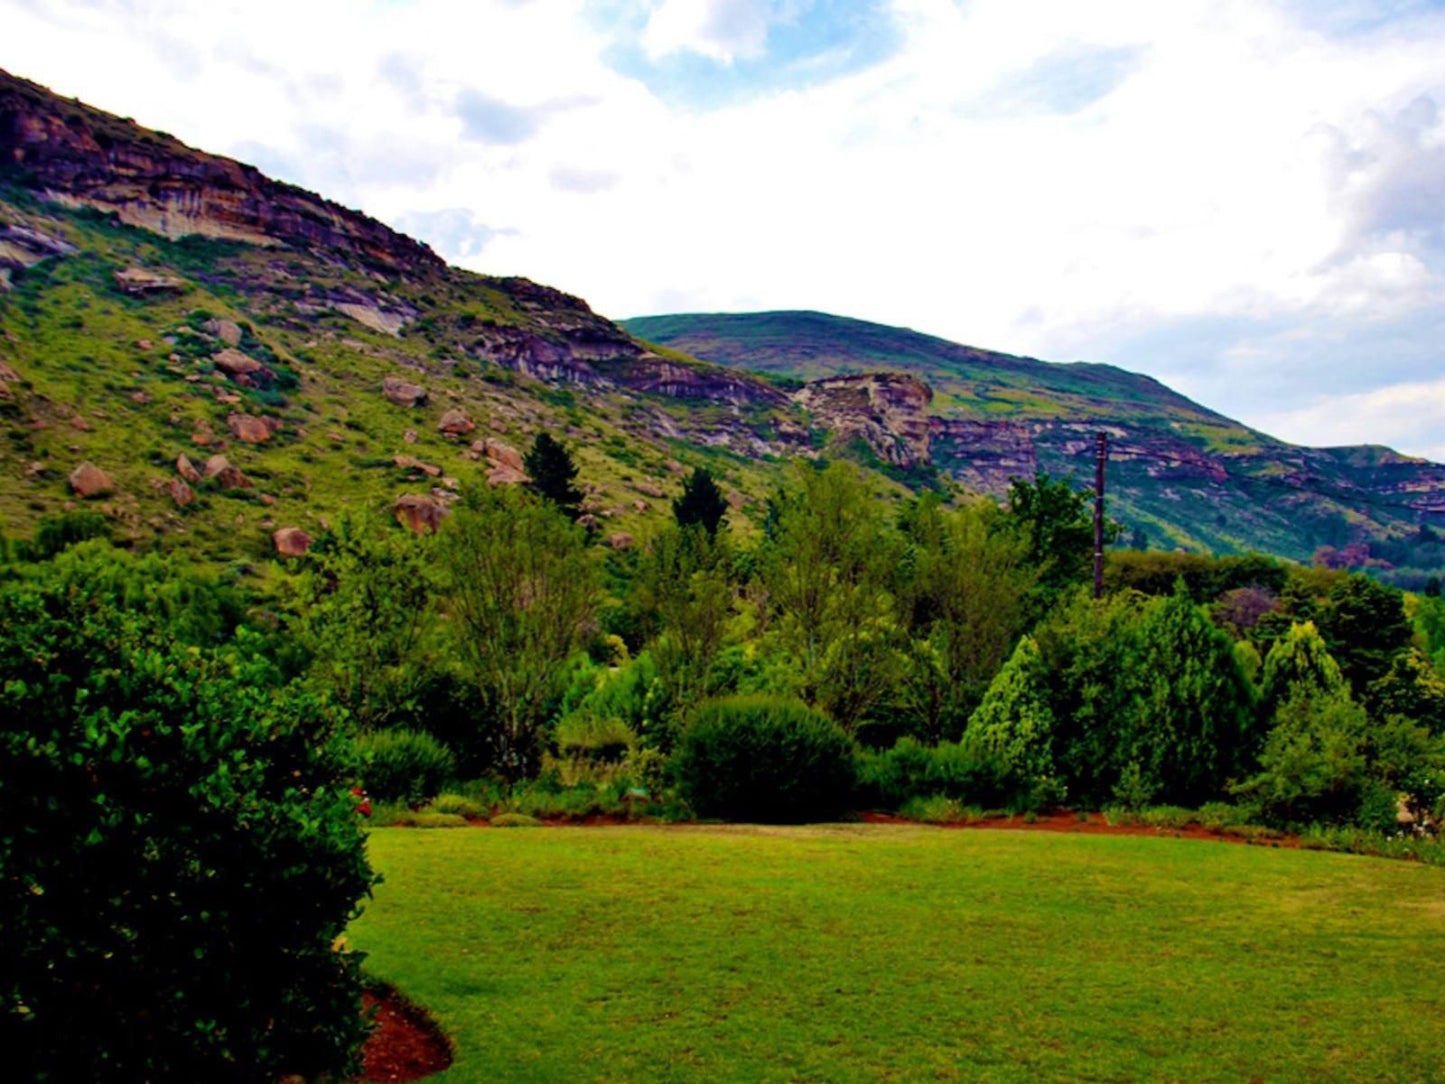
8,0,1445,461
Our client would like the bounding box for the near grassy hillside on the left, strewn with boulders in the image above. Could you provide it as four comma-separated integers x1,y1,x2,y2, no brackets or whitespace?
0,72,902,562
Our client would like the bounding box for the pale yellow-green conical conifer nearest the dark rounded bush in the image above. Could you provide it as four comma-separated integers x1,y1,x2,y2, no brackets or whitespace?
964,636,1065,808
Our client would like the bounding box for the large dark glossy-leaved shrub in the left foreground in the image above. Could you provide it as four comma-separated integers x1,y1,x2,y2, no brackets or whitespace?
0,563,373,1081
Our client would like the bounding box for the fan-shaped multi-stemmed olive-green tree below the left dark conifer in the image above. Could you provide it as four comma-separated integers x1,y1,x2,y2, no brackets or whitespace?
436,487,597,779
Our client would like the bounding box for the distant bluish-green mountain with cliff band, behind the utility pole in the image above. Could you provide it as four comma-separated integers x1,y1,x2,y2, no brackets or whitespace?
621,312,1445,567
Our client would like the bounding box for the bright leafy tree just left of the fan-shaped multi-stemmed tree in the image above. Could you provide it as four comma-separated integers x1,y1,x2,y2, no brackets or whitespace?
292,517,436,727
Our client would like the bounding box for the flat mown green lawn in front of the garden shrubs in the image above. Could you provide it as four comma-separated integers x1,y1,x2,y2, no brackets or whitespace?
351,825,1445,1083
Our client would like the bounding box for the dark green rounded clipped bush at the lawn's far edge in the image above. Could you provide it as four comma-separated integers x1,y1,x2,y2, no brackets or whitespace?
676,697,857,824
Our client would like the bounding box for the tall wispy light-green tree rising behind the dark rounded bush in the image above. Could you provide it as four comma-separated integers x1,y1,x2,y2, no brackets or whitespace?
762,463,903,731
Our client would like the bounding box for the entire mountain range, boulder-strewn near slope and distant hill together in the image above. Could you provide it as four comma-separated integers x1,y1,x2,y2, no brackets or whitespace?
0,72,1445,581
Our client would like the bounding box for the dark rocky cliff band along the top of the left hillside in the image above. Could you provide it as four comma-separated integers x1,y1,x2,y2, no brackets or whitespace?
0,71,444,275
